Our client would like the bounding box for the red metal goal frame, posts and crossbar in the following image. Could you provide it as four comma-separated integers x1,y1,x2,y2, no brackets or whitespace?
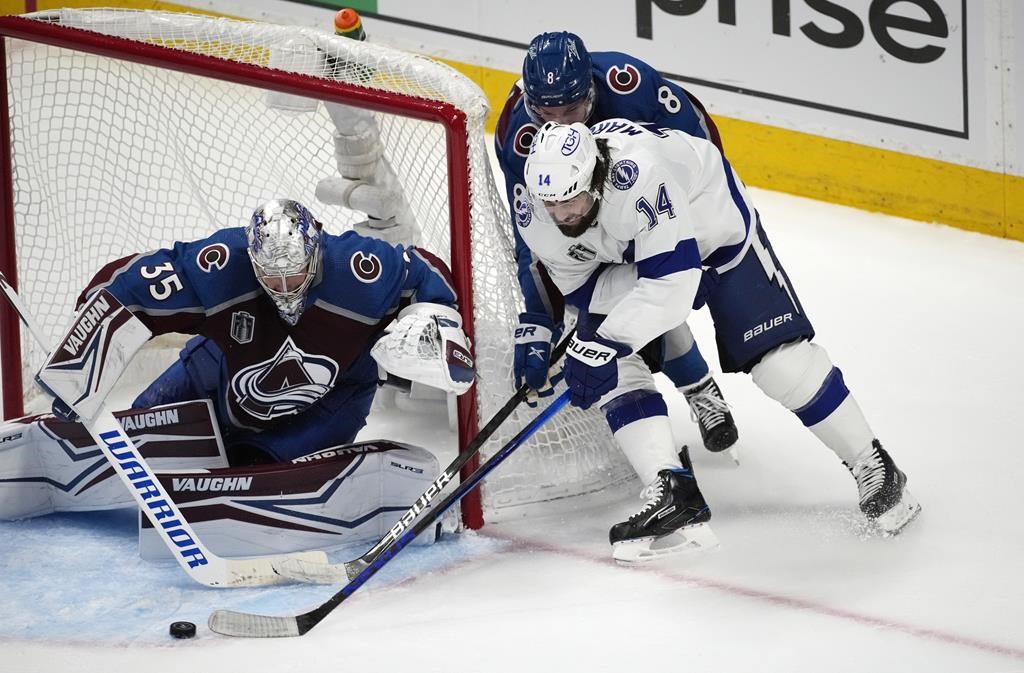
0,16,483,529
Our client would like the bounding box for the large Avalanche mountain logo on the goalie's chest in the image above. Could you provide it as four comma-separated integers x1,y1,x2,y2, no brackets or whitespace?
231,337,341,421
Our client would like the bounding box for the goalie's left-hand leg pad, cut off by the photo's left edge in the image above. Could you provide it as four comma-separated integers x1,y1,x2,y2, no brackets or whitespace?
0,399,227,520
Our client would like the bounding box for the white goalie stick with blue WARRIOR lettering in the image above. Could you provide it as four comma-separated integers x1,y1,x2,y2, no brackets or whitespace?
0,274,327,587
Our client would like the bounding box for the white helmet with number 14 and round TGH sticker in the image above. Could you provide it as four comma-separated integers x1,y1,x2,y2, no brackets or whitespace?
524,122,598,202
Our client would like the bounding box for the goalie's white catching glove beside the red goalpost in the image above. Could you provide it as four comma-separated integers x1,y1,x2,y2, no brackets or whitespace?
370,302,476,394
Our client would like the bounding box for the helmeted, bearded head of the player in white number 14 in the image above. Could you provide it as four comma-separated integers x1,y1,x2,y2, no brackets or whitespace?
524,122,601,238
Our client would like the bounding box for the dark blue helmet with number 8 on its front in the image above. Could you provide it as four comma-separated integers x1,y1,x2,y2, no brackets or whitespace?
522,32,595,124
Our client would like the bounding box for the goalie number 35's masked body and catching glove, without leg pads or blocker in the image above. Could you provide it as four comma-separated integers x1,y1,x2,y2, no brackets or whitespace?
74,200,473,464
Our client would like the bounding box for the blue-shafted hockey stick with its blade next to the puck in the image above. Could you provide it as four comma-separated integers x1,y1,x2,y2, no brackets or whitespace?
208,390,569,638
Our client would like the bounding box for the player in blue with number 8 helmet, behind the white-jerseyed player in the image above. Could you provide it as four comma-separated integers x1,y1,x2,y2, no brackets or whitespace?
495,33,738,451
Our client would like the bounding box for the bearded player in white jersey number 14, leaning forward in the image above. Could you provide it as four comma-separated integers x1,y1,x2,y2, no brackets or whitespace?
517,119,920,560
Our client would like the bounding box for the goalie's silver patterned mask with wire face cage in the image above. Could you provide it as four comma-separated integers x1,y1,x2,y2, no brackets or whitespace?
246,199,323,325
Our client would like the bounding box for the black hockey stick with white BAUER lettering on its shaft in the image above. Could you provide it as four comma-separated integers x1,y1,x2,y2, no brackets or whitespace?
278,332,572,584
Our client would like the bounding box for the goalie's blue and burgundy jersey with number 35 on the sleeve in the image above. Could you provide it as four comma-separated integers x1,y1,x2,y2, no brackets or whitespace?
82,227,457,429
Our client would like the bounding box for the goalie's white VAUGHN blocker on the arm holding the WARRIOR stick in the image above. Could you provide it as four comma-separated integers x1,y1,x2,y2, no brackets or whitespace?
36,290,153,418
